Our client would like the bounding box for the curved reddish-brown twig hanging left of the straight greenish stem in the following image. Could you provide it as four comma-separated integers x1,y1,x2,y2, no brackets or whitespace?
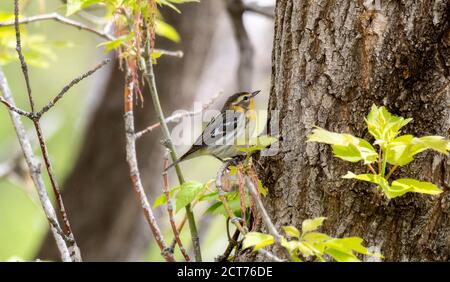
124,64,175,262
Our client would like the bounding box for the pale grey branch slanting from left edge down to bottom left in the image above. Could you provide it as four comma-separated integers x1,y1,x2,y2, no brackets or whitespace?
0,68,72,262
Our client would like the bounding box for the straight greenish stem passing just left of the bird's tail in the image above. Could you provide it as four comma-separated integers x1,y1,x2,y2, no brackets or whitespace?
143,54,202,262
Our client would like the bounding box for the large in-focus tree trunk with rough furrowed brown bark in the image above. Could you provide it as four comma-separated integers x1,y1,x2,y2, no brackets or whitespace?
245,0,450,261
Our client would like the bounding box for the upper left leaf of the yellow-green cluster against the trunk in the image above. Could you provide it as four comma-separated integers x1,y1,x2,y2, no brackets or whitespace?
307,128,378,164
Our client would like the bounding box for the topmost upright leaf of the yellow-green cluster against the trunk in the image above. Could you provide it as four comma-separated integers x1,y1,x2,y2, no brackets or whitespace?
365,105,412,148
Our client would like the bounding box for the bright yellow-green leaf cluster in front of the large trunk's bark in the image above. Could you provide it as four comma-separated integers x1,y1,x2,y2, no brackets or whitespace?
308,105,450,199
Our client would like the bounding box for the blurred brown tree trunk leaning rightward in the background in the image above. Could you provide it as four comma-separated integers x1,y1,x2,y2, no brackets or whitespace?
38,1,220,261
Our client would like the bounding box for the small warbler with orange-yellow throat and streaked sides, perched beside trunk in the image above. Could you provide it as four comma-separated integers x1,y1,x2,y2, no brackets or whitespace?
166,90,261,170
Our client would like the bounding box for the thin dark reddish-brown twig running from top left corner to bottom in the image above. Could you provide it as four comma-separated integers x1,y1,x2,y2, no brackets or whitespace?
14,0,82,261
